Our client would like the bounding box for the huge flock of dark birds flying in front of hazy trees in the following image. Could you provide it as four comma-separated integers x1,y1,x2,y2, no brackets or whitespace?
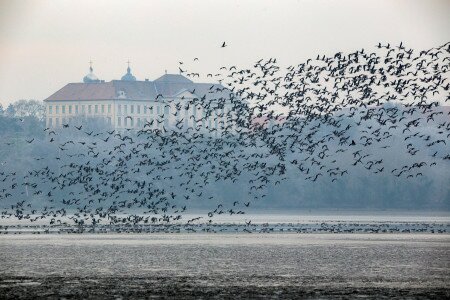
0,43,450,232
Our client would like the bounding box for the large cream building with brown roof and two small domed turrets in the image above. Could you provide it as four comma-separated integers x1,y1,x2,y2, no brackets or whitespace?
44,66,233,131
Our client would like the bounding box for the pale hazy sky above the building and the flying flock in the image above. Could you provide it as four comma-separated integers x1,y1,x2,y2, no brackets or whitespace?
0,0,450,106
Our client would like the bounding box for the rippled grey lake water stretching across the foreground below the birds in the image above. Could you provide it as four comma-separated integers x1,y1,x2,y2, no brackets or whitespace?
0,216,450,299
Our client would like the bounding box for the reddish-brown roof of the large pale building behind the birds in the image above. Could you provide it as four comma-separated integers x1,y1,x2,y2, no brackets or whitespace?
44,74,230,101
